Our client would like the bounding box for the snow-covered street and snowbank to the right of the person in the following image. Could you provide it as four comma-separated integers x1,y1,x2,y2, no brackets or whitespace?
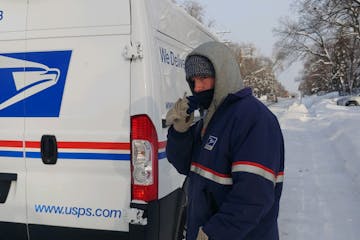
270,94,360,240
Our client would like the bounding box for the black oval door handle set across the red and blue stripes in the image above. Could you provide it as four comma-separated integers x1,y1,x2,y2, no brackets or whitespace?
41,135,58,164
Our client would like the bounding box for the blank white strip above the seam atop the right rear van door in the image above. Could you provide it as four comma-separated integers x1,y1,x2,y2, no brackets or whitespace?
28,0,130,30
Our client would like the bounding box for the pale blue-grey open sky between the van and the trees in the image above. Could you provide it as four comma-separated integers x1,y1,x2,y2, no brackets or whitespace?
197,0,300,91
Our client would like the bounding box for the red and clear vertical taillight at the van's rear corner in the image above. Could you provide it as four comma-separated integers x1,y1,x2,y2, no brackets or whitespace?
131,115,158,202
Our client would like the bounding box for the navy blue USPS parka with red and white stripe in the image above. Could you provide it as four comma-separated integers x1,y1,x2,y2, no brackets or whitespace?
166,43,284,240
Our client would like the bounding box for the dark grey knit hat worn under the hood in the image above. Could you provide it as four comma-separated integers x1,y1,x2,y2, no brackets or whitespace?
185,55,215,81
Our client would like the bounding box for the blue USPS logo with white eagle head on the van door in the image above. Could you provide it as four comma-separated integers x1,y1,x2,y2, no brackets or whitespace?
0,50,71,117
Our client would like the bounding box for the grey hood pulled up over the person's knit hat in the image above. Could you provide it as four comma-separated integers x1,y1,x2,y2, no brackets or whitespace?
186,42,244,131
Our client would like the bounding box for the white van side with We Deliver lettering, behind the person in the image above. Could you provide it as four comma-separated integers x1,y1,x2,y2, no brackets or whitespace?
145,0,216,198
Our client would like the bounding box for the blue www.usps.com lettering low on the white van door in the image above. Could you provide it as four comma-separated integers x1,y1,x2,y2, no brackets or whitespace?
35,204,121,219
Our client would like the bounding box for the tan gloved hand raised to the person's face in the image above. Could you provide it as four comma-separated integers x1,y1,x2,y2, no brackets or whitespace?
166,95,194,132
